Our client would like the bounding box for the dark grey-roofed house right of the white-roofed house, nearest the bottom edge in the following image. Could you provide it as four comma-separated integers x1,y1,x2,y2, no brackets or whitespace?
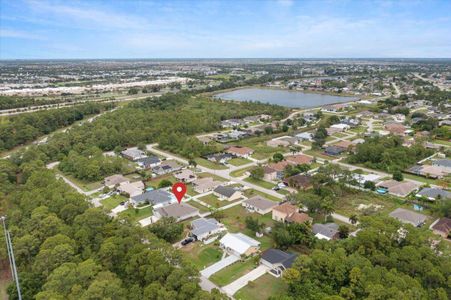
260,248,297,277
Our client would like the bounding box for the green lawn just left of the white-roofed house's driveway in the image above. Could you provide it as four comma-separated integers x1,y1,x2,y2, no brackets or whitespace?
180,242,222,271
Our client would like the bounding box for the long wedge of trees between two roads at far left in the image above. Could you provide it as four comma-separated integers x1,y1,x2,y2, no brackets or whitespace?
0,103,114,151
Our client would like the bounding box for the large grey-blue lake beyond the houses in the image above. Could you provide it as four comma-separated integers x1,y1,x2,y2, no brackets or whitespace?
214,88,358,108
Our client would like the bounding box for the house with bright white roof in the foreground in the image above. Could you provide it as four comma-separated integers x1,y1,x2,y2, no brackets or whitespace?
219,232,260,257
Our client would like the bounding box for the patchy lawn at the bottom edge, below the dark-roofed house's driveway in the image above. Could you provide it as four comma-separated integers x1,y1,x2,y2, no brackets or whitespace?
233,274,287,300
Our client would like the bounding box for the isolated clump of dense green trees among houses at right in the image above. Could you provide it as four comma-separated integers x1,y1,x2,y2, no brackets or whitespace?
348,136,433,172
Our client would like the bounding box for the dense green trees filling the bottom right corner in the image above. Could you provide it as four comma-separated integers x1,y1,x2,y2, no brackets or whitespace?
275,217,451,300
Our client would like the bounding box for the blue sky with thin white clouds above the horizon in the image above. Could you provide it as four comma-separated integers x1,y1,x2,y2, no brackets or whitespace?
0,0,451,59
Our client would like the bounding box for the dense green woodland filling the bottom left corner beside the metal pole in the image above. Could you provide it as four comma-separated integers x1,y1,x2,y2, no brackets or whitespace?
0,165,224,300
